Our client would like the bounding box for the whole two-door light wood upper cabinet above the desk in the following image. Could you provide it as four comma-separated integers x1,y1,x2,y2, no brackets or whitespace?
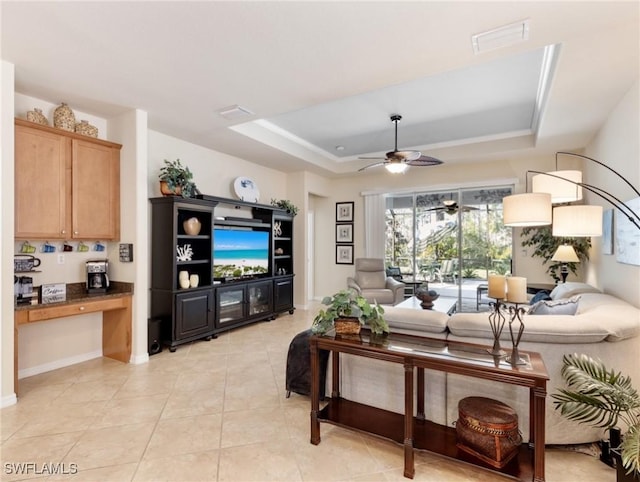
15,119,122,240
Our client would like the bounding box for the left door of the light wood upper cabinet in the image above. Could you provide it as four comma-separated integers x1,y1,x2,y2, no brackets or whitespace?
15,125,71,239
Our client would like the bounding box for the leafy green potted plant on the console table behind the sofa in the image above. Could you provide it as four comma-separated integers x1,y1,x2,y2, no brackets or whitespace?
311,289,389,335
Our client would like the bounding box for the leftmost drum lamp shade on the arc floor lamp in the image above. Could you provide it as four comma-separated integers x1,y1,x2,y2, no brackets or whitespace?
502,192,551,226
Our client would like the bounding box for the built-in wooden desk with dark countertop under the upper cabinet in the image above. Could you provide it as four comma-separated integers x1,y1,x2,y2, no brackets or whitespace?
13,282,133,395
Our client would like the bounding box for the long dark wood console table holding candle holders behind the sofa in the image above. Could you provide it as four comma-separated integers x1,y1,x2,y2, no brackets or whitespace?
311,331,549,482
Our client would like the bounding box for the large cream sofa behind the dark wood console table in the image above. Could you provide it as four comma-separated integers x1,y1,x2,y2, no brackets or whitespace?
336,283,640,444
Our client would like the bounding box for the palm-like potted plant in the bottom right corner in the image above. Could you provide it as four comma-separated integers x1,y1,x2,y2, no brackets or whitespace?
552,354,640,481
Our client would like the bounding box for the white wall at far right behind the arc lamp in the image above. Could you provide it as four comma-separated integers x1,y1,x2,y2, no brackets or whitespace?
585,80,640,307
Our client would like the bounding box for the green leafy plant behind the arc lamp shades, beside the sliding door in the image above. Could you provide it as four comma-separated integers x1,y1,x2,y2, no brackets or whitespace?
522,226,591,282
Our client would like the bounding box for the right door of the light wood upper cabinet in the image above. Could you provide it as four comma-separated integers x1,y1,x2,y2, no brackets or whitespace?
71,139,120,240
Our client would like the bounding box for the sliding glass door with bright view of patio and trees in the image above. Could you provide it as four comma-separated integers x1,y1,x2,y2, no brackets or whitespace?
385,187,512,310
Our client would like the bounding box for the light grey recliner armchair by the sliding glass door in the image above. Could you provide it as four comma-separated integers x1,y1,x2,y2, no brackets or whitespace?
347,258,404,305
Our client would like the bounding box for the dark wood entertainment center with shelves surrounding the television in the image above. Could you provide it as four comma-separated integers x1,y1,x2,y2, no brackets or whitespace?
149,195,294,351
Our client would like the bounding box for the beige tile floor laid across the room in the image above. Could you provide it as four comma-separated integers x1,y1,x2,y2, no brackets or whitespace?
0,305,615,482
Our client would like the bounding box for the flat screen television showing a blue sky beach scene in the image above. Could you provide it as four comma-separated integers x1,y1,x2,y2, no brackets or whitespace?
213,227,269,279
